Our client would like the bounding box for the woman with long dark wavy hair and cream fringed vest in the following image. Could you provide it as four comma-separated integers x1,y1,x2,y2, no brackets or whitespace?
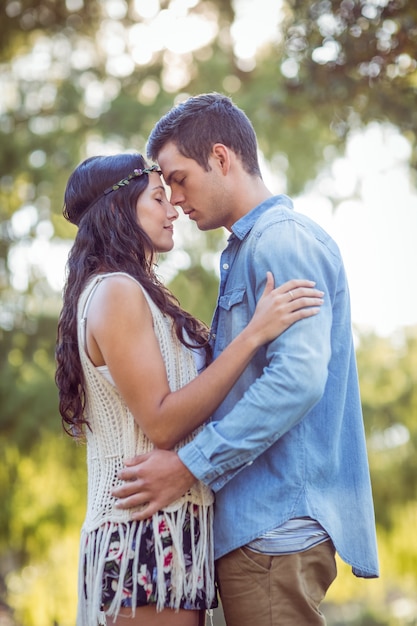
56,154,322,626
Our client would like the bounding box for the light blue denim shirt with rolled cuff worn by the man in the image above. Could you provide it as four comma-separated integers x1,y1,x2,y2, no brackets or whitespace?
179,195,378,577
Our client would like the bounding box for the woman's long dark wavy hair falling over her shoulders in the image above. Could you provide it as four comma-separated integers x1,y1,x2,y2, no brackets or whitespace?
55,153,211,437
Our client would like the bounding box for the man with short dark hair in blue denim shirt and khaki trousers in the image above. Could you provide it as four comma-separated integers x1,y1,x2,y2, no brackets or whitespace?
115,94,378,626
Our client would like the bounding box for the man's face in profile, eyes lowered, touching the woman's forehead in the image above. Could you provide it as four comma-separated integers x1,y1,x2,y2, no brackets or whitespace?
158,142,233,230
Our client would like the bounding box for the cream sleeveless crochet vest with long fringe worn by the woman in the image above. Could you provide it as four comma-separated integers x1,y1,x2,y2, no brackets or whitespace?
77,272,214,626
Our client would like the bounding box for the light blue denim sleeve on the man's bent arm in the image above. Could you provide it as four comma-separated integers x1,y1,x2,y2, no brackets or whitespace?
179,211,342,491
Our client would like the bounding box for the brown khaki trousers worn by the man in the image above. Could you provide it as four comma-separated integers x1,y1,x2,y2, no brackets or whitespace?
216,541,337,626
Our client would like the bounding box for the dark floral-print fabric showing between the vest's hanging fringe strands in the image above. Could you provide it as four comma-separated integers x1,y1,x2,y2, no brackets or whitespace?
89,505,218,611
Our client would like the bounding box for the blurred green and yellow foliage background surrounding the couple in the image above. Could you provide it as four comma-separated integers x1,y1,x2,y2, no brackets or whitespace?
0,0,417,626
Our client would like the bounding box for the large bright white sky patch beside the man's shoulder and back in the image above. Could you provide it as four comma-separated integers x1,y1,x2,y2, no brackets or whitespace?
297,124,417,335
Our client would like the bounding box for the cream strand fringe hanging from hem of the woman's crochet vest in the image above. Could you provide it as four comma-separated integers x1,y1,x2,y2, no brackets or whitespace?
77,502,215,626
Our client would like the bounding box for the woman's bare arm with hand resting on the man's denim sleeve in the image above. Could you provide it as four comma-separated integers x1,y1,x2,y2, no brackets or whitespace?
87,273,323,449
